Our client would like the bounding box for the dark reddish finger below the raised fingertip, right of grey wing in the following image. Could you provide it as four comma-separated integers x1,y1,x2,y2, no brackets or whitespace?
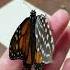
45,27,70,70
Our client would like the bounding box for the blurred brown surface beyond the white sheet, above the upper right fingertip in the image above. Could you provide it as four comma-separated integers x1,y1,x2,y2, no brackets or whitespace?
27,0,70,14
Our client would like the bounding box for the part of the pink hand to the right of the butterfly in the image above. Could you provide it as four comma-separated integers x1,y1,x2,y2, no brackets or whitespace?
44,9,70,70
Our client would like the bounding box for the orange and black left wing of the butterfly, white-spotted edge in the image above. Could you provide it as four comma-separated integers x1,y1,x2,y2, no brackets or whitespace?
9,18,31,64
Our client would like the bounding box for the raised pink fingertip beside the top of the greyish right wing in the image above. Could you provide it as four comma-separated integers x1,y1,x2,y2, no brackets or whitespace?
50,9,69,42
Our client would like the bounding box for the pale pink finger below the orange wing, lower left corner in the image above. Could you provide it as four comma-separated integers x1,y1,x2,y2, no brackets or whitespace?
0,50,23,70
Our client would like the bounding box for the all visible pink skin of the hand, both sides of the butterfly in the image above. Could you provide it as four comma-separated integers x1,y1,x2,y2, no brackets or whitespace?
0,9,70,70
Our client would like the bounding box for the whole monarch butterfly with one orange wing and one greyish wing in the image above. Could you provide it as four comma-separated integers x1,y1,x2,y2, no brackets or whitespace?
9,10,54,70
